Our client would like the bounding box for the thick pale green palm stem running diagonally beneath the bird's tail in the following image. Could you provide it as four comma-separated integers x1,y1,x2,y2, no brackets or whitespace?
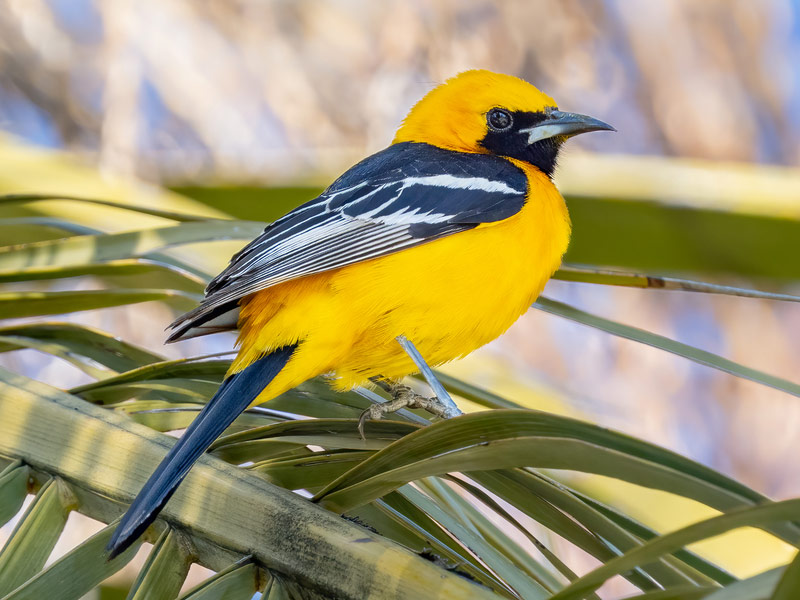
0,368,492,600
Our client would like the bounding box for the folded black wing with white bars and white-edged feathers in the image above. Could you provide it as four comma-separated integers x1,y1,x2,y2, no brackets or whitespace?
169,142,528,341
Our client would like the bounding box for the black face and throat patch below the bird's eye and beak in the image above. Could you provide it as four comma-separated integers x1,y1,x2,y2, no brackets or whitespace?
480,111,564,178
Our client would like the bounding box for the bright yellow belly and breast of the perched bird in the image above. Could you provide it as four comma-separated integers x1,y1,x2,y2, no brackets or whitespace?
231,163,570,402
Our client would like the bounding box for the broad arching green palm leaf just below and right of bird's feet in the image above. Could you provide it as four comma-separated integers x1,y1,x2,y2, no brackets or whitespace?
316,410,798,542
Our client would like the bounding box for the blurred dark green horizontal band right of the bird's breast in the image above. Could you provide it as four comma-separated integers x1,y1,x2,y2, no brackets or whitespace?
564,192,800,281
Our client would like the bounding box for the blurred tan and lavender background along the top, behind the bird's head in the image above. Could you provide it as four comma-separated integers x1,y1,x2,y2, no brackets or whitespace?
0,0,800,176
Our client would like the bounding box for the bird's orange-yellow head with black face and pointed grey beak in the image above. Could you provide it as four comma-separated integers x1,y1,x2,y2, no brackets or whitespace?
394,70,616,176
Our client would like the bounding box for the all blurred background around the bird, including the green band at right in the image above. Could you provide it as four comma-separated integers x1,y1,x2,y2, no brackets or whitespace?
0,0,800,592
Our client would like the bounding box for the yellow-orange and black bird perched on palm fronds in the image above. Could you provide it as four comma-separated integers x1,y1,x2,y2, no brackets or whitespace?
107,70,616,557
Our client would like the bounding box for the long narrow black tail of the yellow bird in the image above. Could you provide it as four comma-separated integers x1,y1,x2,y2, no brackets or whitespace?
106,345,297,558
